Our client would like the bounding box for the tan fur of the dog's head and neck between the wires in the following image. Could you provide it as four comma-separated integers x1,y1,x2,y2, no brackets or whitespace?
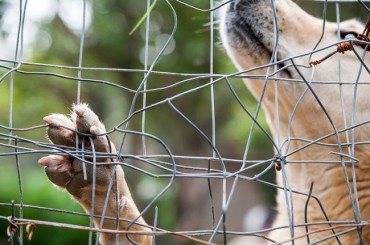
221,0,370,244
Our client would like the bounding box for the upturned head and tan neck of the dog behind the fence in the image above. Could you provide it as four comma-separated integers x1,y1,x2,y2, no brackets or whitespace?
220,0,370,244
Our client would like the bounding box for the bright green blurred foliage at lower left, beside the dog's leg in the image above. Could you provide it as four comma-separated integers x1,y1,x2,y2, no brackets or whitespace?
0,157,89,244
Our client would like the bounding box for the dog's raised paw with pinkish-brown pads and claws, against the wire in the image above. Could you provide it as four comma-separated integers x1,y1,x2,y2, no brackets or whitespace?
39,104,115,198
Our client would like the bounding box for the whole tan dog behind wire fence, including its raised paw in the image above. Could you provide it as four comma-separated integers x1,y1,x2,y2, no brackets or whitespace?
39,0,370,245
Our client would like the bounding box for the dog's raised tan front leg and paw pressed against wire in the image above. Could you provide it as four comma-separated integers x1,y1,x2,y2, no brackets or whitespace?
39,104,152,244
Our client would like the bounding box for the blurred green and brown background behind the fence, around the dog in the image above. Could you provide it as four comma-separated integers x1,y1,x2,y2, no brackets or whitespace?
0,0,367,244
